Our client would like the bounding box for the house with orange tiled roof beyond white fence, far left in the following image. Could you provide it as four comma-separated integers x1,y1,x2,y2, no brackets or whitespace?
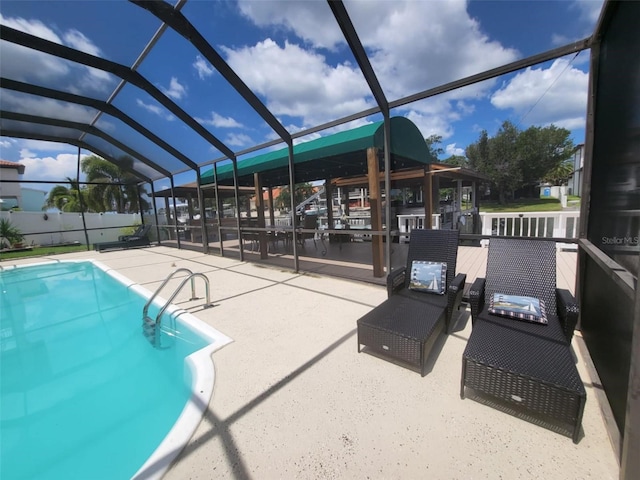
0,160,47,212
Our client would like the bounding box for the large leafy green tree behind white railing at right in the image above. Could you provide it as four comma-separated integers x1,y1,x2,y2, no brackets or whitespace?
466,121,574,204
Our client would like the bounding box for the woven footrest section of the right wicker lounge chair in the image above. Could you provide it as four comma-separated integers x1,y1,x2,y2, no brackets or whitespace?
460,318,587,443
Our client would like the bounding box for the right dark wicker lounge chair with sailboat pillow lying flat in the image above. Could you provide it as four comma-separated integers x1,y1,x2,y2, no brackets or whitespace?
460,239,586,443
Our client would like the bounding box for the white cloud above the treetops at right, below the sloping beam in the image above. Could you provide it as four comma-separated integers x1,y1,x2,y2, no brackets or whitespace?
491,58,589,129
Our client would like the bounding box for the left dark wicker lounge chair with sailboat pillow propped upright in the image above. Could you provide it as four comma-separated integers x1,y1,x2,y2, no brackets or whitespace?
358,230,466,376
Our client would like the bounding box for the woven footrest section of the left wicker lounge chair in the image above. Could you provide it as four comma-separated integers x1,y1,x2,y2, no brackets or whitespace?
358,293,446,376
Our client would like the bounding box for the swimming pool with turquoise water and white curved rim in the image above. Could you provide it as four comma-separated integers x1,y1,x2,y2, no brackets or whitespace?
0,261,231,479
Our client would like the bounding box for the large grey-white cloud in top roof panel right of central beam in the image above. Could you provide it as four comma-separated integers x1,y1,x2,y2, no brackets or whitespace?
347,0,519,100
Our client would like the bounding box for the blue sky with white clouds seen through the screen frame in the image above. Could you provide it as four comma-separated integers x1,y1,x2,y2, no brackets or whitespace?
0,0,602,195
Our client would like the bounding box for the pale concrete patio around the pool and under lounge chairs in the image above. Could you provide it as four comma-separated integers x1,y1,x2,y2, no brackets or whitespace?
3,247,619,480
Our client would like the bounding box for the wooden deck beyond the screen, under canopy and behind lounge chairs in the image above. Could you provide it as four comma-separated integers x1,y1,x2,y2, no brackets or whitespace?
163,239,577,298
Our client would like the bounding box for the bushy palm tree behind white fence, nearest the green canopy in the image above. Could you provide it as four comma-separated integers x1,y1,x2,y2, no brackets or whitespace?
81,155,149,213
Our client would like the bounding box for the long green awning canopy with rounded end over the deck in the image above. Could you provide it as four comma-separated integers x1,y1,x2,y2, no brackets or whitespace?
201,117,436,186
